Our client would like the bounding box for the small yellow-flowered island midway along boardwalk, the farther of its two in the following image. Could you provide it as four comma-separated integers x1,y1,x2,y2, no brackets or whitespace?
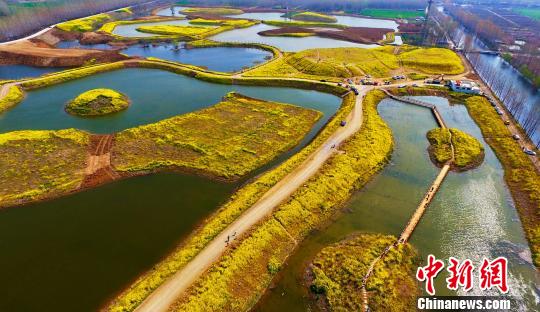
427,128,484,170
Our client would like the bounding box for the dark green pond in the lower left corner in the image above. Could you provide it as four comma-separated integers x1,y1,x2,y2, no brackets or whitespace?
0,174,236,312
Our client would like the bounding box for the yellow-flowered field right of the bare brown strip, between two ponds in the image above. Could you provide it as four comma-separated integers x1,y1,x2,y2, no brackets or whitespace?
113,93,321,179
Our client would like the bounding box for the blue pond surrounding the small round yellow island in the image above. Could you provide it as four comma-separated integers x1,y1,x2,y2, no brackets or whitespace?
0,68,340,133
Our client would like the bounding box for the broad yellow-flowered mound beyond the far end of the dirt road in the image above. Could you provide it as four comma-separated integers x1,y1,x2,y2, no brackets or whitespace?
247,46,464,78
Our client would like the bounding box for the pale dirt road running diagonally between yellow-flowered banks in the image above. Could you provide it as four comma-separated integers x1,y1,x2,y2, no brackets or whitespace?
136,88,371,312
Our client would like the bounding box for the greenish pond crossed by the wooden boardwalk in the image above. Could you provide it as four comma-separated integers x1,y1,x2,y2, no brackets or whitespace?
254,97,540,312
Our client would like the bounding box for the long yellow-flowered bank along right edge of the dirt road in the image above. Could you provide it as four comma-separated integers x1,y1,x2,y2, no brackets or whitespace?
168,91,392,311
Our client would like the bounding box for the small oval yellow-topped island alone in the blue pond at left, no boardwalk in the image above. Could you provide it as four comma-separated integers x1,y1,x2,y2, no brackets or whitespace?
66,89,130,117
